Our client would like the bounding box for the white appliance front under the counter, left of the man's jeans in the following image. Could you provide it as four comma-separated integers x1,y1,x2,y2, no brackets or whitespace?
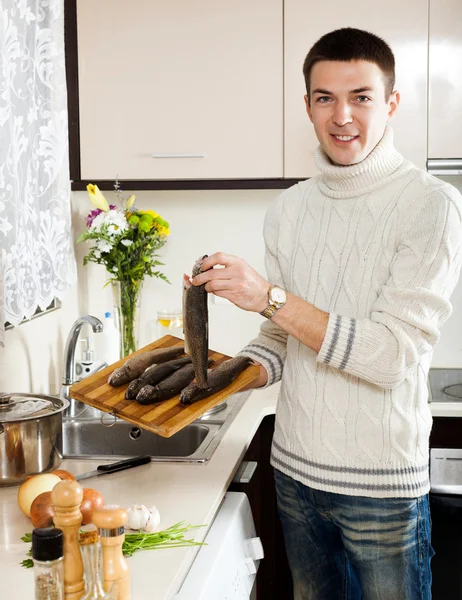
174,492,263,600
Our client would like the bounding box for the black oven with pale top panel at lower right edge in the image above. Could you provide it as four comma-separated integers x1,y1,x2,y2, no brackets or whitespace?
430,448,462,600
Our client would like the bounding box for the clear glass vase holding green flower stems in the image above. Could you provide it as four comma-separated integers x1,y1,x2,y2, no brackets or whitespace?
111,279,143,358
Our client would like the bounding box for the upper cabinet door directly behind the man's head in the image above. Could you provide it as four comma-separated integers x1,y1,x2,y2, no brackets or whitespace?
284,0,428,177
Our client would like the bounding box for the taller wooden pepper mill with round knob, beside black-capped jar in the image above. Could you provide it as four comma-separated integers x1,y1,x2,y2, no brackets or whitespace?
51,480,85,600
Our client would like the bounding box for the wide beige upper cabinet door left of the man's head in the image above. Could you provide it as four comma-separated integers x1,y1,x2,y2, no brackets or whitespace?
77,0,283,180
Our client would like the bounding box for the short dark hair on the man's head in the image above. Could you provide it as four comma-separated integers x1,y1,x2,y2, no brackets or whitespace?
303,27,395,101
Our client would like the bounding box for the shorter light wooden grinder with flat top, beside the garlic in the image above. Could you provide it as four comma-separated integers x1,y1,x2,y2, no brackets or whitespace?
92,506,130,600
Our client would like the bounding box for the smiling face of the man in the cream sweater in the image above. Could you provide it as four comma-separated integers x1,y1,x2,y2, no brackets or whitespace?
305,60,399,165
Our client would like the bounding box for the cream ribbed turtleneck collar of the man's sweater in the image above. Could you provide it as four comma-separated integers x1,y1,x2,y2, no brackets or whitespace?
314,125,404,198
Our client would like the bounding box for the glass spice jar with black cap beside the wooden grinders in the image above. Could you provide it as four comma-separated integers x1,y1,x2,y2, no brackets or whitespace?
32,528,64,600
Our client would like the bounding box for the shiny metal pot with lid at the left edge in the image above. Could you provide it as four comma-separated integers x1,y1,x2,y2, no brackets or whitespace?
0,394,69,486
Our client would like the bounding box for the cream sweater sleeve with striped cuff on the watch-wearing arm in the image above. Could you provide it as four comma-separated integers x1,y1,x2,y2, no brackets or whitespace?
317,186,462,388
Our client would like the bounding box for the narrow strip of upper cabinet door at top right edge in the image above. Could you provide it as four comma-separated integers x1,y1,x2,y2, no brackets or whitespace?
428,0,462,159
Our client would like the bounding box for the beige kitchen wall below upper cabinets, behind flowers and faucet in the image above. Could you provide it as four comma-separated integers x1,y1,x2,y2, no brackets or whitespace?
0,177,462,393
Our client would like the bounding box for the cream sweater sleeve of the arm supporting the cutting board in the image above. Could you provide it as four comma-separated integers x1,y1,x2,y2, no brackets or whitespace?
239,188,290,387
